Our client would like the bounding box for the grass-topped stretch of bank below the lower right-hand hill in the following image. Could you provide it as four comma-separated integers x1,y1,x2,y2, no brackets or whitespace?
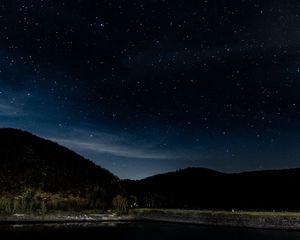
130,209,300,230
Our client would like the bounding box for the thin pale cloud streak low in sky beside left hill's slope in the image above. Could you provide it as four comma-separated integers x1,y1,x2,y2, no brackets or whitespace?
44,127,210,160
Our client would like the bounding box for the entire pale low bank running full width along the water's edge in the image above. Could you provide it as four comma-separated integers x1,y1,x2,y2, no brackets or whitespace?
0,209,300,230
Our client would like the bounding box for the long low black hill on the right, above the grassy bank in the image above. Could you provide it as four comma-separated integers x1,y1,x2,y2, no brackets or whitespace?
123,168,300,210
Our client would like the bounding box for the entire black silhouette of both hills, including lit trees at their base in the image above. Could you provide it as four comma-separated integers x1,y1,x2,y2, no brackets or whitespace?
0,129,300,214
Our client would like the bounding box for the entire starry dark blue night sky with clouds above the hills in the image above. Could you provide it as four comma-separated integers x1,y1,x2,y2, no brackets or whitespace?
0,0,300,179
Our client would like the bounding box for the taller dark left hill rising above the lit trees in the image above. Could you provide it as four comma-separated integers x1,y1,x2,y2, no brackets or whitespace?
0,129,120,213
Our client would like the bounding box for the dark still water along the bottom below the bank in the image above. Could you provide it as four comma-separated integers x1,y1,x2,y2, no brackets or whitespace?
0,222,300,240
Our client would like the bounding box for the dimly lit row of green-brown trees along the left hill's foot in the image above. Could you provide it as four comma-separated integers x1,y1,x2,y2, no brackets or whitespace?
0,189,133,215
